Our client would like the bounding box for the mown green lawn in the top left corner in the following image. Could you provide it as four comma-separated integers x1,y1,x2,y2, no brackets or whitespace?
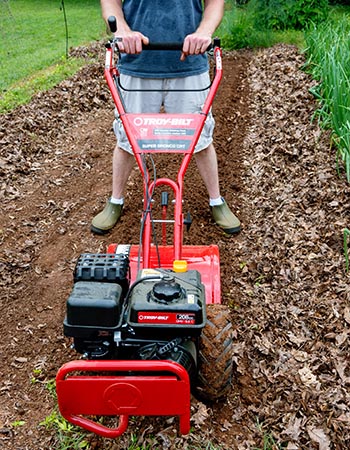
0,0,106,112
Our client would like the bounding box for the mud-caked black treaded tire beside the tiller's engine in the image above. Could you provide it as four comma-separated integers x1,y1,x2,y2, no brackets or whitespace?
196,304,233,401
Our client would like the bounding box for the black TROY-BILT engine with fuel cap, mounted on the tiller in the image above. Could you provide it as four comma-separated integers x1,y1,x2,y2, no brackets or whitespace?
64,253,206,378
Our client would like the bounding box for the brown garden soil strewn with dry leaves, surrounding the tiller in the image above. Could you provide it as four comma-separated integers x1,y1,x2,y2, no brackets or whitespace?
0,46,350,450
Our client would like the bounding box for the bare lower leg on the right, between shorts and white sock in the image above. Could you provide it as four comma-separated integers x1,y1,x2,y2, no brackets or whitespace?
195,144,220,198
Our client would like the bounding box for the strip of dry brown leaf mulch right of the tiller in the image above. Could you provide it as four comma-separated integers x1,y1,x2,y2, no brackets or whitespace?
233,45,350,450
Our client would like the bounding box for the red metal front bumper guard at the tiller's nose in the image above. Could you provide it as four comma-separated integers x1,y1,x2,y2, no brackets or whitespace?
56,361,191,438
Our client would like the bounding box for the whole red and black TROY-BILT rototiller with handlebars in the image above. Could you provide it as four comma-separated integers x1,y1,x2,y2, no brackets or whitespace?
56,18,233,438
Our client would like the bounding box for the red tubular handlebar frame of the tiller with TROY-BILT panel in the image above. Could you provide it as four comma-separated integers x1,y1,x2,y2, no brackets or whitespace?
105,38,222,268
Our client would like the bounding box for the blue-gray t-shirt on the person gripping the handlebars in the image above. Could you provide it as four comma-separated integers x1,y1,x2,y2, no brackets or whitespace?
119,0,208,78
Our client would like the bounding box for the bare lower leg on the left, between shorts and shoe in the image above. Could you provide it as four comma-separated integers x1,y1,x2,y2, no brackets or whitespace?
112,146,135,198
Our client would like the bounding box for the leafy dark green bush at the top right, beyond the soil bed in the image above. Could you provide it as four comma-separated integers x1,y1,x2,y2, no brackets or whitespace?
249,0,329,30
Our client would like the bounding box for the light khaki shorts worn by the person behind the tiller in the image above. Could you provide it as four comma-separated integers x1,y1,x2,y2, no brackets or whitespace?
113,73,215,153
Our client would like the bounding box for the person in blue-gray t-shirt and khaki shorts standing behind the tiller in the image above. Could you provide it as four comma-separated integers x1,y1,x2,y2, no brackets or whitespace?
91,0,241,234
